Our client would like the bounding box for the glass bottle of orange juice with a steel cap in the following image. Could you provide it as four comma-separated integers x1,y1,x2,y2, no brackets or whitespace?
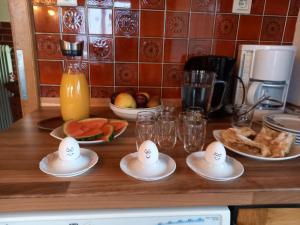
60,41,90,121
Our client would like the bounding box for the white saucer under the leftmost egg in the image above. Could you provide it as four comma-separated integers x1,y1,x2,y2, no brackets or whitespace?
39,148,98,177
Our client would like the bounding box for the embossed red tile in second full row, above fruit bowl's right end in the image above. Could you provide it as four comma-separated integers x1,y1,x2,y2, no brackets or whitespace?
140,38,163,62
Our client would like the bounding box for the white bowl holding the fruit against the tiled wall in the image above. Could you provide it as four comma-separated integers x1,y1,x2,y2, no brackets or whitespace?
109,103,162,121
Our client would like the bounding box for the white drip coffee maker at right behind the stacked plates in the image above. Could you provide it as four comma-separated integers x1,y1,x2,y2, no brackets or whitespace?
234,45,296,120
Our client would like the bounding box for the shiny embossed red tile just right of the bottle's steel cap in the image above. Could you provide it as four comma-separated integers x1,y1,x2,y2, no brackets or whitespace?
89,36,113,61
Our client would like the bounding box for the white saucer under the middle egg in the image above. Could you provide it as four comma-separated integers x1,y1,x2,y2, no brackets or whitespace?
120,152,176,181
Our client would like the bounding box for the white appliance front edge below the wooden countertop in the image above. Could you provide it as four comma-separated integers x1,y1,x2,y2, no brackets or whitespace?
0,207,230,225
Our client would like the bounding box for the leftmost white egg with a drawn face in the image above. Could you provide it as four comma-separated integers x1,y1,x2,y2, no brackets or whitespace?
58,137,80,161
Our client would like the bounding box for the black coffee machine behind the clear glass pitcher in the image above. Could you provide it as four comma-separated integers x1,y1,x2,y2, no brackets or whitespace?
184,55,236,117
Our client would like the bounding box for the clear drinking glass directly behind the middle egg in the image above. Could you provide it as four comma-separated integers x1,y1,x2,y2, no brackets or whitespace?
135,111,156,150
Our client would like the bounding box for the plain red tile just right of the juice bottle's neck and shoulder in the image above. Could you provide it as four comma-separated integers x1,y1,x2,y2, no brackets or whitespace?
90,63,114,86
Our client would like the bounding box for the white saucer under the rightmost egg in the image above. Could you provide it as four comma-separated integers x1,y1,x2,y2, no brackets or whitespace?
186,151,244,181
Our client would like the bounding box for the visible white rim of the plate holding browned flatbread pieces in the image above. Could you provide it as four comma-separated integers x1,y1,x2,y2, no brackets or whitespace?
213,130,300,161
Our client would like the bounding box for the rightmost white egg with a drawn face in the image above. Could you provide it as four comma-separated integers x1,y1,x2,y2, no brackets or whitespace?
204,141,226,165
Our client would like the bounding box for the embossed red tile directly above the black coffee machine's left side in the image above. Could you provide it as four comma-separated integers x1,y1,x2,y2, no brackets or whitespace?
188,39,212,57
